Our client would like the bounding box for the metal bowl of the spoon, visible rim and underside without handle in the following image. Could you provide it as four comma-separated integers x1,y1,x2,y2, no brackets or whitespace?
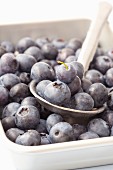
30,80,105,123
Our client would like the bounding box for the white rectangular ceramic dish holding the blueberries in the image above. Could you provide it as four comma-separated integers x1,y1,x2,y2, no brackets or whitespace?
0,19,113,170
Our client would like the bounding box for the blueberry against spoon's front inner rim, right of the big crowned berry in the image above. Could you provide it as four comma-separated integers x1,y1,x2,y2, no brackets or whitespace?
74,92,94,111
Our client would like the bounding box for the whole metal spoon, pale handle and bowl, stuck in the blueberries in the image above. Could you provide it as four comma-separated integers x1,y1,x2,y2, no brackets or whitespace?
30,2,112,124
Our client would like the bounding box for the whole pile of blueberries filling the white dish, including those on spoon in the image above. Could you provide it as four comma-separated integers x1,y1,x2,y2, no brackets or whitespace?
0,37,113,146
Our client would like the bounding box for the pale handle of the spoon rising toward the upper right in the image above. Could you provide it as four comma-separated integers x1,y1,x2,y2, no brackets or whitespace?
78,2,112,72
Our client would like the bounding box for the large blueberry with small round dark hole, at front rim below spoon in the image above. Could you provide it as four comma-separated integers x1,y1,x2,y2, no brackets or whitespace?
49,122,74,143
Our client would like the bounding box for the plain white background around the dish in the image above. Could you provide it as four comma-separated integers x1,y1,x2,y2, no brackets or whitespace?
0,0,113,170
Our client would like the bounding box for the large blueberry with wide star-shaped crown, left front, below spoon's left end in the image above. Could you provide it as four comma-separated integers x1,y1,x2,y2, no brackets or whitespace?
15,105,40,130
